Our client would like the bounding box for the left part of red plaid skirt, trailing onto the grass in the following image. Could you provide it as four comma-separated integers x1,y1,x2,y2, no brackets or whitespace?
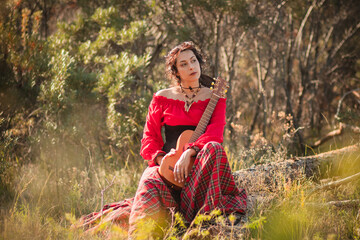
80,167,178,232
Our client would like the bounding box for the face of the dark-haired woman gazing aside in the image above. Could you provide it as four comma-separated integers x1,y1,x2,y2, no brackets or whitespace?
176,50,201,84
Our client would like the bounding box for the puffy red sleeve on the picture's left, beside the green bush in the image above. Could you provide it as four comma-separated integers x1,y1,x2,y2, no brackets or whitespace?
140,94,165,166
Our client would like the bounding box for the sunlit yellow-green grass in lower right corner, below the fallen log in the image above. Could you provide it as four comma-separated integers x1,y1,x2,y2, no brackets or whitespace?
244,149,360,239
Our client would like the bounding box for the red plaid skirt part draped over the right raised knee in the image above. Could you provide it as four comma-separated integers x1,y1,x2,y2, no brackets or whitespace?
180,142,246,223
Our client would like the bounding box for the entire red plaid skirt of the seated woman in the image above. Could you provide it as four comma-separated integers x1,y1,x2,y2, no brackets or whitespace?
81,142,247,233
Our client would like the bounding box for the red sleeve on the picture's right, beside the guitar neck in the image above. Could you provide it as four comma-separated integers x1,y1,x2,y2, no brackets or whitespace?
189,98,226,149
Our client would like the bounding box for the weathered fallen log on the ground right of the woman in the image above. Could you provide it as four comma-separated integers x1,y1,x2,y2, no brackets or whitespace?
233,144,360,209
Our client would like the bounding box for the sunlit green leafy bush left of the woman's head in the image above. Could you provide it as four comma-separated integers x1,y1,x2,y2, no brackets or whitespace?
39,7,153,168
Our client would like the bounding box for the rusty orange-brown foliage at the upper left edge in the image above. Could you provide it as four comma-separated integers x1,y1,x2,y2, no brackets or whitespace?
0,8,47,98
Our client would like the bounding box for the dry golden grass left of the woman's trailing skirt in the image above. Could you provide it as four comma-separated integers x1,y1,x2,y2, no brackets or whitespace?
0,147,145,239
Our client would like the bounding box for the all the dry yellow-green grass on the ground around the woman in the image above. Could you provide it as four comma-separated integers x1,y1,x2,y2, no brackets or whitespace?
0,123,360,240
